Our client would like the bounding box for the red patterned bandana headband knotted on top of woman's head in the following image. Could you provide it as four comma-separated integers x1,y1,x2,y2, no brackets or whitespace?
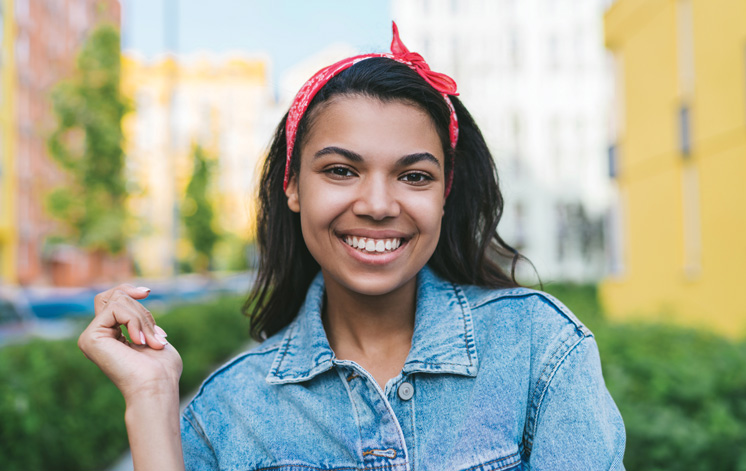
282,22,458,196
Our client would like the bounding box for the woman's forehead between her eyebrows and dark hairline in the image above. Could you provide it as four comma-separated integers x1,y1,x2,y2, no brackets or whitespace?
301,96,443,162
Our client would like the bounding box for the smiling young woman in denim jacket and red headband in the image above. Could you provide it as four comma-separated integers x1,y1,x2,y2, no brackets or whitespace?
79,23,625,471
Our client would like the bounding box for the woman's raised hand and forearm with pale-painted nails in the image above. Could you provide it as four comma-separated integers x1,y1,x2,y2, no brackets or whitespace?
78,284,184,471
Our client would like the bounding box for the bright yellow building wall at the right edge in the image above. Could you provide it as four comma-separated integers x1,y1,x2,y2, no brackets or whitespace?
600,0,746,336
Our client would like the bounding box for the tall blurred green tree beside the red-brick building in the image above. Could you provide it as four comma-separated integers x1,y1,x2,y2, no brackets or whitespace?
47,25,129,253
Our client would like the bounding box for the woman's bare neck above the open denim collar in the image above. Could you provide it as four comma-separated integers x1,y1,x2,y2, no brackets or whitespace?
324,276,417,364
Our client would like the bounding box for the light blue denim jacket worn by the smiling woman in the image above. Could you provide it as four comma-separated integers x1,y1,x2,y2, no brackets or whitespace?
181,267,625,471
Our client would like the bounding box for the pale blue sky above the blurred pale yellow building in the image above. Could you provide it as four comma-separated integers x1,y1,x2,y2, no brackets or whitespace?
121,0,391,81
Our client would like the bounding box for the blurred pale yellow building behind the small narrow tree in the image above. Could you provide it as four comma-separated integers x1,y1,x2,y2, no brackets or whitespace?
122,55,281,277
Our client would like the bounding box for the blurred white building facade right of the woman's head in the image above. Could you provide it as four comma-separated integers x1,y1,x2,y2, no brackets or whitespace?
391,0,612,283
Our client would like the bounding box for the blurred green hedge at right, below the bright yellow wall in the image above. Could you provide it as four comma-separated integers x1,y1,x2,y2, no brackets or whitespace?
545,285,746,471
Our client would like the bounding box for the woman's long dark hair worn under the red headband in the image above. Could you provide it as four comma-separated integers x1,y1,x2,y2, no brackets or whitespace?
243,58,523,340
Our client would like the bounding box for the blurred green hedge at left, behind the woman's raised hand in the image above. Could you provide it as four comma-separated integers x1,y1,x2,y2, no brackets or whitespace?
0,298,249,471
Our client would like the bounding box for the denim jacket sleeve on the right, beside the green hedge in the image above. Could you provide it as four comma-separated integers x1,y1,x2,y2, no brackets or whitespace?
524,336,626,471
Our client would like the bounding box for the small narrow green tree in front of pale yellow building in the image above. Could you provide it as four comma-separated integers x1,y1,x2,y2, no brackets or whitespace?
181,145,220,271
